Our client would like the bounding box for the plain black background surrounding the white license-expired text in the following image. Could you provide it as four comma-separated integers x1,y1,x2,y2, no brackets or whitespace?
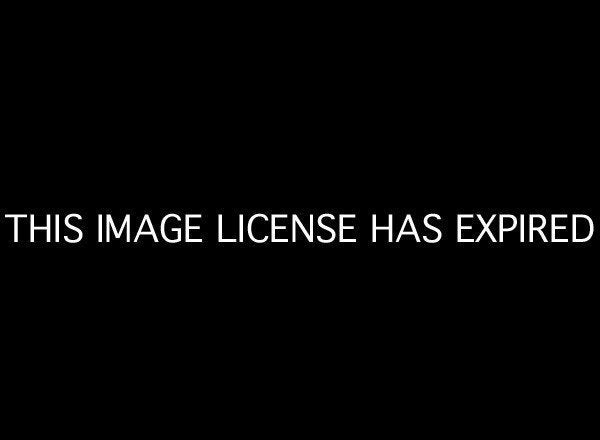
1,5,598,433
